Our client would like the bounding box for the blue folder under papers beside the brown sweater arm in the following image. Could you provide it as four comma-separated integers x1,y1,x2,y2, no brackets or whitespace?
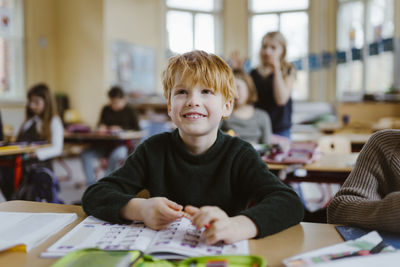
335,226,400,249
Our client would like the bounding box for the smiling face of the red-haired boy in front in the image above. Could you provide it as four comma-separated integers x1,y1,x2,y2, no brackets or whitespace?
168,78,233,141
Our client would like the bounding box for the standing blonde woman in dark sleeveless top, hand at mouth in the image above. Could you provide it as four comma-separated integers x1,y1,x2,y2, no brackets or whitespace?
250,32,295,138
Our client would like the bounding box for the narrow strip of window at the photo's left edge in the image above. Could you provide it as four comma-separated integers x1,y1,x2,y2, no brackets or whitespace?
0,0,25,102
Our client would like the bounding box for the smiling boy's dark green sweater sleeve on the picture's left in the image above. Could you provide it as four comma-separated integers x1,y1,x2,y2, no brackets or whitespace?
82,144,147,223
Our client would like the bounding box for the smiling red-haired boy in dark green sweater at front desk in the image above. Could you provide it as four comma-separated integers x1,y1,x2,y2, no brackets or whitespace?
82,51,303,244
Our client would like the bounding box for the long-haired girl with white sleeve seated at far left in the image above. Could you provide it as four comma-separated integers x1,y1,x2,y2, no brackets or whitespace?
17,84,64,161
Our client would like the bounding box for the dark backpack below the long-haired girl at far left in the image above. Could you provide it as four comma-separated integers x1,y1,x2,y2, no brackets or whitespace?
12,163,63,203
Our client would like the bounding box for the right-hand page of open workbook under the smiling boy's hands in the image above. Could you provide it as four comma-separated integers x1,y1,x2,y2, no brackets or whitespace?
145,217,249,259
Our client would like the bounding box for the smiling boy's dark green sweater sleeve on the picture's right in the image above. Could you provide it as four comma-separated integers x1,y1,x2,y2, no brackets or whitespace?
237,149,304,238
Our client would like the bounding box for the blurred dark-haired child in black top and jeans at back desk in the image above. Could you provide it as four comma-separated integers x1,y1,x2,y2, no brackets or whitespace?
81,86,139,185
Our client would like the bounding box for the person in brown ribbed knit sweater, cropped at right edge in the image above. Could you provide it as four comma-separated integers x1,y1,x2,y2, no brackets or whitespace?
328,130,400,233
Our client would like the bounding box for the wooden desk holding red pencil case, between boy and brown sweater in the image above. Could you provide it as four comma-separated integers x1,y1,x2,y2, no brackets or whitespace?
268,153,359,184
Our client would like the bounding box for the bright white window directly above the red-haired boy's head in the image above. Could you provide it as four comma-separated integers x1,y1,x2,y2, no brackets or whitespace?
166,0,221,56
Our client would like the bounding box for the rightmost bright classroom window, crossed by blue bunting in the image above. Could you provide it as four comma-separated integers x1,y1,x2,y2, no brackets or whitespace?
336,0,394,100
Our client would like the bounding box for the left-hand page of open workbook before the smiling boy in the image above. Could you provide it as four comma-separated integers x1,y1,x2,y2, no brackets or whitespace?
41,216,157,257
